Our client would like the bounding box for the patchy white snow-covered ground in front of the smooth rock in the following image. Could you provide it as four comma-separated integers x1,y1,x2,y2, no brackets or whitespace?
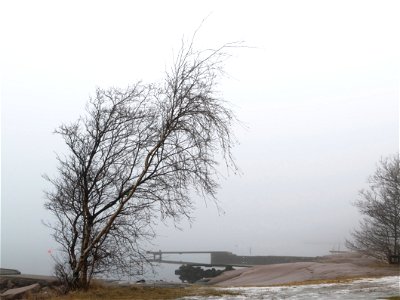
182,276,400,300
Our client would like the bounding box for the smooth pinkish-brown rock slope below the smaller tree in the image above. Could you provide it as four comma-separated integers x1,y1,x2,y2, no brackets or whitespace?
208,253,400,287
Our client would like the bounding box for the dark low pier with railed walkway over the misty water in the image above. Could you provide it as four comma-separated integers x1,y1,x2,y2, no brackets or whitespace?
147,250,316,267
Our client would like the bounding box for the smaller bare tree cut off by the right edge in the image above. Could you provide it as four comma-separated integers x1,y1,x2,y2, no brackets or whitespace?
347,154,400,263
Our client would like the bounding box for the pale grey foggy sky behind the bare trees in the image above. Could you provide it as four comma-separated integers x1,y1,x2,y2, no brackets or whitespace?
0,0,400,274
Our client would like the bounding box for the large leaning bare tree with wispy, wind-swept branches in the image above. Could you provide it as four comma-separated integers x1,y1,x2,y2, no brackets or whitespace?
46,44,236,288
